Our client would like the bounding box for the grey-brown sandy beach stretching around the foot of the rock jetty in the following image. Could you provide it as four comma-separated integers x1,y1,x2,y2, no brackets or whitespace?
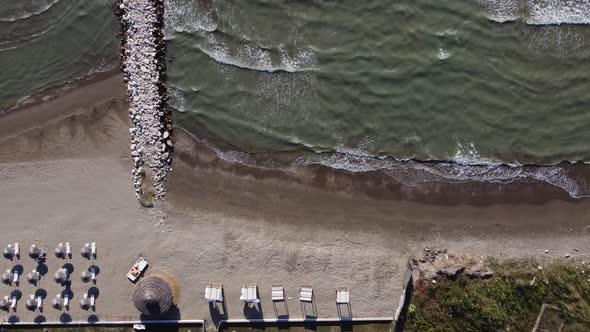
0,74,590,327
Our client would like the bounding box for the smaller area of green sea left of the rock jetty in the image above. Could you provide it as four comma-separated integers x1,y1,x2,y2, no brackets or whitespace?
0,0,119,108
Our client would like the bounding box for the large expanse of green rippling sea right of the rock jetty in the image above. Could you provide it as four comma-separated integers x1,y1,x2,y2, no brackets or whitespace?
166,0,590,164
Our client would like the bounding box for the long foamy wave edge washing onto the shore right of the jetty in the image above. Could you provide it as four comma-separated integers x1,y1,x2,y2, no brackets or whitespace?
177,127,590,198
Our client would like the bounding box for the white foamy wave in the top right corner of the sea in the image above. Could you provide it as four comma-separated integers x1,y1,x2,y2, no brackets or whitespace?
476,0,590,25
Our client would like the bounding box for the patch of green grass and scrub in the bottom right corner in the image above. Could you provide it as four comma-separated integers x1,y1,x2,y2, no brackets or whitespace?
405,259,590,332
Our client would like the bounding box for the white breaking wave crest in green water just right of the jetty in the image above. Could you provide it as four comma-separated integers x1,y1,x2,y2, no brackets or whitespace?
197,33,317,73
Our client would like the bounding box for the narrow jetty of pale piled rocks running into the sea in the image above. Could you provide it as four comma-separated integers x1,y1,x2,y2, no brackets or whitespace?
115,0,173,207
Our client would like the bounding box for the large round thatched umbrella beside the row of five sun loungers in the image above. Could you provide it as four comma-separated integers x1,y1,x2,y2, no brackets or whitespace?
133,276,173,317
